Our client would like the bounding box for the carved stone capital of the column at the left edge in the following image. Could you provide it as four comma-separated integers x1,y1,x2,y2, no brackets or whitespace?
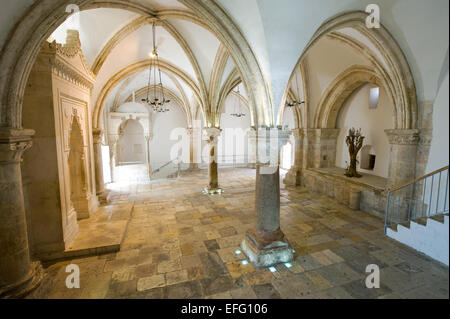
0,128,35,165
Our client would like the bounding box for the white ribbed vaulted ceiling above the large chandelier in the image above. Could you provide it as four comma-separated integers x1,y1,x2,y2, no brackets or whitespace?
49,4,245,124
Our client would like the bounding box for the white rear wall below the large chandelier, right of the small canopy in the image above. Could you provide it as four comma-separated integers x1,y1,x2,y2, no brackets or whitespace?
150,102,187,170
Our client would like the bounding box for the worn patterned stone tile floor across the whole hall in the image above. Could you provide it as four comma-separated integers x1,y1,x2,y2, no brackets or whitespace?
29,169,449,299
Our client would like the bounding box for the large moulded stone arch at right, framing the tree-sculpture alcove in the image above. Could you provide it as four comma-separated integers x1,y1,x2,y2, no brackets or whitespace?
277,11,418,130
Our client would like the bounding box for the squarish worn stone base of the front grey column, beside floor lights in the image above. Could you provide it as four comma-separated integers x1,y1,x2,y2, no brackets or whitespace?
241,232,294,268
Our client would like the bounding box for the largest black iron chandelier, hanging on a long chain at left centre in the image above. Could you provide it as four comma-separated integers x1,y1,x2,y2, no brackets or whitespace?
142,22,170,113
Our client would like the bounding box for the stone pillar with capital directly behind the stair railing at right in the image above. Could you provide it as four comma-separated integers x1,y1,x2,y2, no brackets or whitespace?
385,130,420,188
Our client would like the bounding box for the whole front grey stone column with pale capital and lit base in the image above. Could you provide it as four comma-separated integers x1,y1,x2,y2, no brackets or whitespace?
241,129,293,267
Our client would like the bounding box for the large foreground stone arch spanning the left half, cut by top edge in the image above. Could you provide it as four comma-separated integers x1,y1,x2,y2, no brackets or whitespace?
0,0,273,129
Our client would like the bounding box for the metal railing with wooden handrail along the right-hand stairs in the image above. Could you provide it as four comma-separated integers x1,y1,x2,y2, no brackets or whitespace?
384,166,449,233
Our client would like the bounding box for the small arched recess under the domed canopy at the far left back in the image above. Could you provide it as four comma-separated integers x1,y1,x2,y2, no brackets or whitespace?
118,119,147,165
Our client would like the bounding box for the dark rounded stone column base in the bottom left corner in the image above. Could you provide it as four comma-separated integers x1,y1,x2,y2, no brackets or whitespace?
0,262,44,299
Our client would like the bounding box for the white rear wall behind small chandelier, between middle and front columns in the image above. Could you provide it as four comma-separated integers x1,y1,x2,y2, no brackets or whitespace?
218,94,250,164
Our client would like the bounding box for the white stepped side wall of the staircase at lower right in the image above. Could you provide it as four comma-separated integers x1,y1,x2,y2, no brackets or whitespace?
387,216,449,266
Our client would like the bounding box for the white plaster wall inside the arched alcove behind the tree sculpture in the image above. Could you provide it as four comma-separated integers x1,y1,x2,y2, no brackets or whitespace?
336,84,394,178
